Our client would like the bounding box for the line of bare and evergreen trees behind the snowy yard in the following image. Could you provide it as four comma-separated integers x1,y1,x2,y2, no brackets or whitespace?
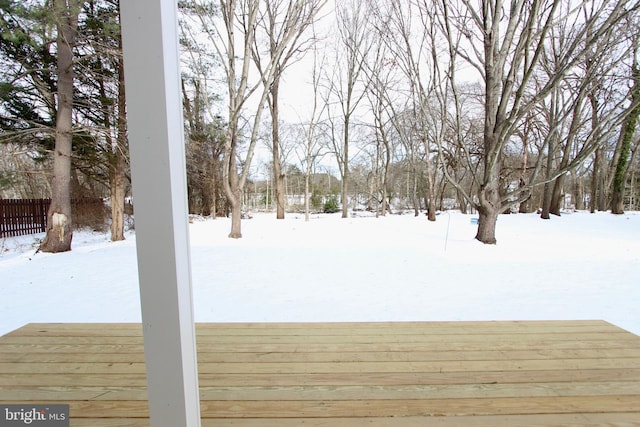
0,0,640,252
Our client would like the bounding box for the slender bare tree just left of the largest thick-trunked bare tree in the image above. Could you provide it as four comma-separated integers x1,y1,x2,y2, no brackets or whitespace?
378,0,468,221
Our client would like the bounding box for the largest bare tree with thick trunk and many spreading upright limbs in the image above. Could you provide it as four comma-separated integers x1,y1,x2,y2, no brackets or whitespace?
442,0,638,244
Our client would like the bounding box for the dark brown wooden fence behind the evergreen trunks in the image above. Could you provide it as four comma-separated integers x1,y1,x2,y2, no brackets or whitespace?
0,199,103,237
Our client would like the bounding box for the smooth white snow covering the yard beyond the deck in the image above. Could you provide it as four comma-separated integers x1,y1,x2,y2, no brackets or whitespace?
0,212,640,335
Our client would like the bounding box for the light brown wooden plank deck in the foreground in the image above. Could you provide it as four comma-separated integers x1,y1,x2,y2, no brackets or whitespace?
0,321,640,427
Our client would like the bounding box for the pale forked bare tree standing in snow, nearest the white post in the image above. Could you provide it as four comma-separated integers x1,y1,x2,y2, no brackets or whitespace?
199,0,318,238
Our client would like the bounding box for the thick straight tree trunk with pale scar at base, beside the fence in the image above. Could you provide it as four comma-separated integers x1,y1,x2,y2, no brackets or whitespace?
40,0,79,252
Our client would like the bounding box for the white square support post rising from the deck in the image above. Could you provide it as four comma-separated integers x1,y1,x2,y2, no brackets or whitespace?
120,0,200,427
